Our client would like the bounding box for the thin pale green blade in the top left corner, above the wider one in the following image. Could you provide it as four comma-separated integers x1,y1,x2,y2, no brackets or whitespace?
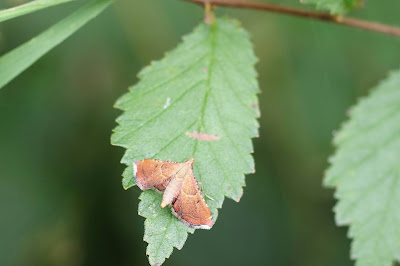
0,0,75,22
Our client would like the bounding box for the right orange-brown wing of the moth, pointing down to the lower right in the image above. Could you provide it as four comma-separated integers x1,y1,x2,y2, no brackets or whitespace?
172,172,213,229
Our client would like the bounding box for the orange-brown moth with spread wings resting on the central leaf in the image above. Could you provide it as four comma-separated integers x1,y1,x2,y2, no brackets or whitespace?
133,158,213,229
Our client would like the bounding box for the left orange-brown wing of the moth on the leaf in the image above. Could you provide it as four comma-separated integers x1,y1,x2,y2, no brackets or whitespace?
133,159,179,192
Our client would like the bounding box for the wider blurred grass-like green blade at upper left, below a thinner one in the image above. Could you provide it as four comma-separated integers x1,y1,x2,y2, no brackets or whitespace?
0,0,112,88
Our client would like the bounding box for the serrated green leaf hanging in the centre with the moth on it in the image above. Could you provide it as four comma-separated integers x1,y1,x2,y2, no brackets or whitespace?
111,19,259,264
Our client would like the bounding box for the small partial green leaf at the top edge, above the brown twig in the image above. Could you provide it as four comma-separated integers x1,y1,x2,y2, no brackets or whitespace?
301,0,364,14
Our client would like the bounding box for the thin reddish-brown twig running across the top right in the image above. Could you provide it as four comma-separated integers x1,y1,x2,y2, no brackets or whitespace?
184,0,400,37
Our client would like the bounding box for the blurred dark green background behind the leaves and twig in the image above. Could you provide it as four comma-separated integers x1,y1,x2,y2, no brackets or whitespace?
0,0,400,266
